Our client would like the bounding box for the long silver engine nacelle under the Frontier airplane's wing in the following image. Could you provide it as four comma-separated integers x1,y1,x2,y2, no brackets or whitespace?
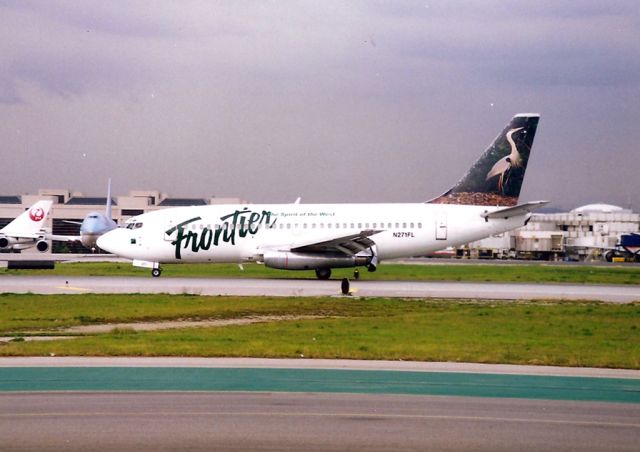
262,251,371,270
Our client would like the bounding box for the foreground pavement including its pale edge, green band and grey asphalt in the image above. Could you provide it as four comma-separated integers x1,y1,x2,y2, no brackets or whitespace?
0,357,640,450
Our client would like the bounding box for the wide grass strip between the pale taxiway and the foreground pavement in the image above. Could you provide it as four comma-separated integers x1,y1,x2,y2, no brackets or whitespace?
0,295,640,369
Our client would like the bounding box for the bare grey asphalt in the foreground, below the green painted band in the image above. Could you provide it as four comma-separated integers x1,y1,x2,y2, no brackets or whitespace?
0,392,640,451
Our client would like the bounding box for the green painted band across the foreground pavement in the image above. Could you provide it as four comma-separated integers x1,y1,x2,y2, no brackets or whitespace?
0,367,640,403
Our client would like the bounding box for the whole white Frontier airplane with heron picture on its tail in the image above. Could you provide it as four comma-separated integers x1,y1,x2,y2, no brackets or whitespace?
97,113,548,279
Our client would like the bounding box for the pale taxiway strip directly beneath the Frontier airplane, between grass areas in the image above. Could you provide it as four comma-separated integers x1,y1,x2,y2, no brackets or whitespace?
0,275,640,303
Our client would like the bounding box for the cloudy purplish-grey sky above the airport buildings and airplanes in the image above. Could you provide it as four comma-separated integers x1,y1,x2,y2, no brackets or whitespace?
0,0,640,211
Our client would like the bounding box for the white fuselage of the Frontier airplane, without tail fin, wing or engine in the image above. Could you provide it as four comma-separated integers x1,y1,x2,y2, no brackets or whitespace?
98,203,530,263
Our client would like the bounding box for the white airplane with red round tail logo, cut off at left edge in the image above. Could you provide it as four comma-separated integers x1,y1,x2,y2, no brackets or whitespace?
0,200,53,253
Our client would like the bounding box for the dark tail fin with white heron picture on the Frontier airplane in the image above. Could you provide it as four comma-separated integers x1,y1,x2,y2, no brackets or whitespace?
428,113,540,206
